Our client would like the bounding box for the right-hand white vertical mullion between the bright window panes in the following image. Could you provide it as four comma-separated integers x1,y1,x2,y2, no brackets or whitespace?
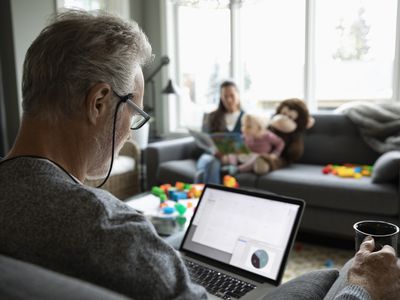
304,0,318,112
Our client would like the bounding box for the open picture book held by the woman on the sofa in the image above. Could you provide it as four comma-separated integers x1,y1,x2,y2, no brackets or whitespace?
189,129,250,155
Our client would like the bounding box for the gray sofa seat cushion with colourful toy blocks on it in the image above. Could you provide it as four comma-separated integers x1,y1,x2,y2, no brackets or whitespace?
257,164,399,216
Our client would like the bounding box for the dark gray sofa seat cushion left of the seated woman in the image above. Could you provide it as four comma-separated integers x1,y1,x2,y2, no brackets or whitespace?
157,159,201,184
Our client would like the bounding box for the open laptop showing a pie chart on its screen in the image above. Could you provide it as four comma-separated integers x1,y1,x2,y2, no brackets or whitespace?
179,184,305,299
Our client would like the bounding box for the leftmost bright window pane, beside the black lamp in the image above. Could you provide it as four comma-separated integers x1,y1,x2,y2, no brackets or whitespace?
177,6,231,125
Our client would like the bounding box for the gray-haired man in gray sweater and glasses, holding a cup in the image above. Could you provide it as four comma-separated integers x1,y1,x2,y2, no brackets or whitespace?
0,12,399,299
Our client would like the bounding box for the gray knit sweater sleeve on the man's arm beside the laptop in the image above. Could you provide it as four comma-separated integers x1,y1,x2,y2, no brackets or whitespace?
80,193,207,299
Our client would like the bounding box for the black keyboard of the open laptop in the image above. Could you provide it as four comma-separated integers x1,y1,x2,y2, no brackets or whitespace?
185,260,256,299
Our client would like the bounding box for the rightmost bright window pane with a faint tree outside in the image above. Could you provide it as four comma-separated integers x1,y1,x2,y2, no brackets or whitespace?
315,0,397,108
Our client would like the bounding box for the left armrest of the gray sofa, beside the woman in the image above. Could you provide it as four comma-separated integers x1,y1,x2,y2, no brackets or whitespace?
145,137,198,189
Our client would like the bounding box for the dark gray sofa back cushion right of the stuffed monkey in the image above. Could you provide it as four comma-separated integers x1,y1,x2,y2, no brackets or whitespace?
299,113,379,165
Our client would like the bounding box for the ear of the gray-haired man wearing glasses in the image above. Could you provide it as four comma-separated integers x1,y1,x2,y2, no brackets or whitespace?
85,83,112,124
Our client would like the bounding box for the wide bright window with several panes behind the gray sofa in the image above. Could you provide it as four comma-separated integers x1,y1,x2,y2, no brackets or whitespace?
169,0,400,131
